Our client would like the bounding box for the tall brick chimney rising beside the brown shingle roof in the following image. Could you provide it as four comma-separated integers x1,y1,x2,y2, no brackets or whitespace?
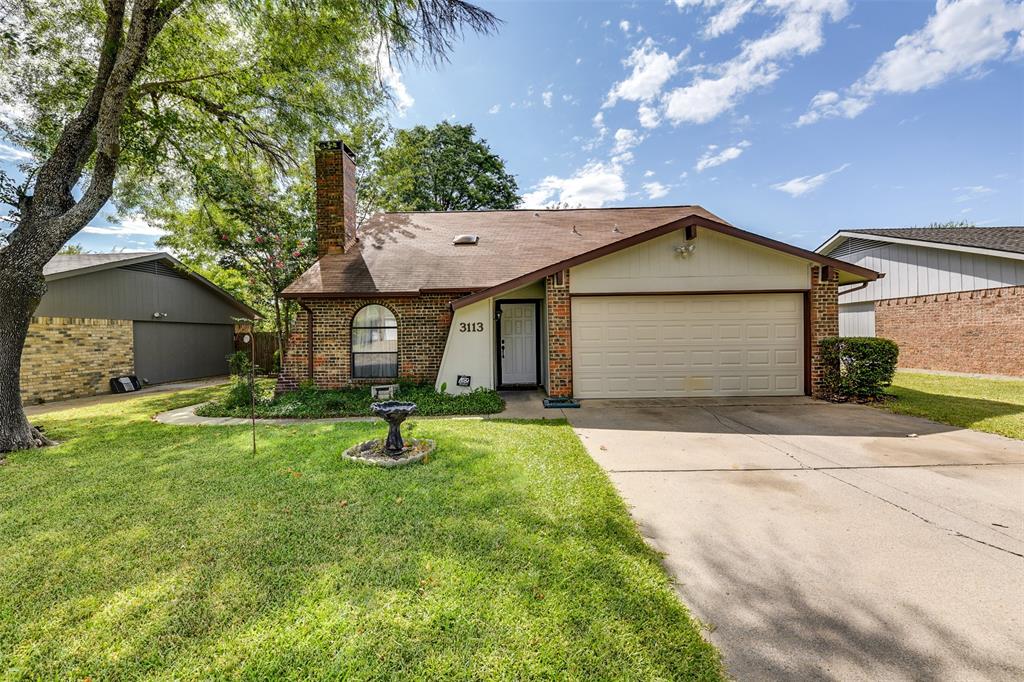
316,140,355,257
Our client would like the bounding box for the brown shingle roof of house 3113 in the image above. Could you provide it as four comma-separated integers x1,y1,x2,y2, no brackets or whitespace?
285,206,877,298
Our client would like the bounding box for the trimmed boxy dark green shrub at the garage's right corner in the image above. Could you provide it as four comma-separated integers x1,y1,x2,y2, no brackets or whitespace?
821,336,899,400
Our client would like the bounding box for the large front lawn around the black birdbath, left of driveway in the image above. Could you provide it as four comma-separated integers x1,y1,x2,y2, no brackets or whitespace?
0,390,723,680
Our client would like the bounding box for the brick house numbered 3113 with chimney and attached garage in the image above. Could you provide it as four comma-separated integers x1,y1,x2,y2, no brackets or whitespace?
279,142,879,398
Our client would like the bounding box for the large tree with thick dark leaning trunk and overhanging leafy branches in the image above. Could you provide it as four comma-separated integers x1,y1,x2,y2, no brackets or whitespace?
0,0,497,453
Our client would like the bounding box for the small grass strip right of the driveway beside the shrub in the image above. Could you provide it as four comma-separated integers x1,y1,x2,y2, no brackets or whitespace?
880,372,1024,439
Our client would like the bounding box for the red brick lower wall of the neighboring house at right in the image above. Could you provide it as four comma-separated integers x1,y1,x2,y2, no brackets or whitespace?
874,287,1024,377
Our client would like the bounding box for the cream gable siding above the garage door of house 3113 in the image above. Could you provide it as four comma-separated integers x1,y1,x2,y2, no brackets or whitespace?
569,228,810,294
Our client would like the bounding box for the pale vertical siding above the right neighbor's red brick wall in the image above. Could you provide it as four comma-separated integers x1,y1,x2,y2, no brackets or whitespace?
840,243,1024,303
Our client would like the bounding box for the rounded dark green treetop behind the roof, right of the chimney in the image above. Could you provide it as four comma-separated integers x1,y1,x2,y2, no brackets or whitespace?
359,122,520,211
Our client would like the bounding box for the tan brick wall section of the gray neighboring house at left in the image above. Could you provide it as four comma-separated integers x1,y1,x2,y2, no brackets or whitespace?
22,317,135,404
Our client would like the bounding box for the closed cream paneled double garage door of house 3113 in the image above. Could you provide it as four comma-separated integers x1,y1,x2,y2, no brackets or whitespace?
572,294,804,398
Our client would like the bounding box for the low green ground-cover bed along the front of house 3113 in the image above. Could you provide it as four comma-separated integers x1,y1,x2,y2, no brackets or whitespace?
197,381,505,419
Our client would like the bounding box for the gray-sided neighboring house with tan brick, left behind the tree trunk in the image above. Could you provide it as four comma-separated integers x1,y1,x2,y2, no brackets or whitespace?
22,253,256,403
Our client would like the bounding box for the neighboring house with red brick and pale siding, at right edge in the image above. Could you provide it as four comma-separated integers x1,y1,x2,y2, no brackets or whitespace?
818,227,1024,376
